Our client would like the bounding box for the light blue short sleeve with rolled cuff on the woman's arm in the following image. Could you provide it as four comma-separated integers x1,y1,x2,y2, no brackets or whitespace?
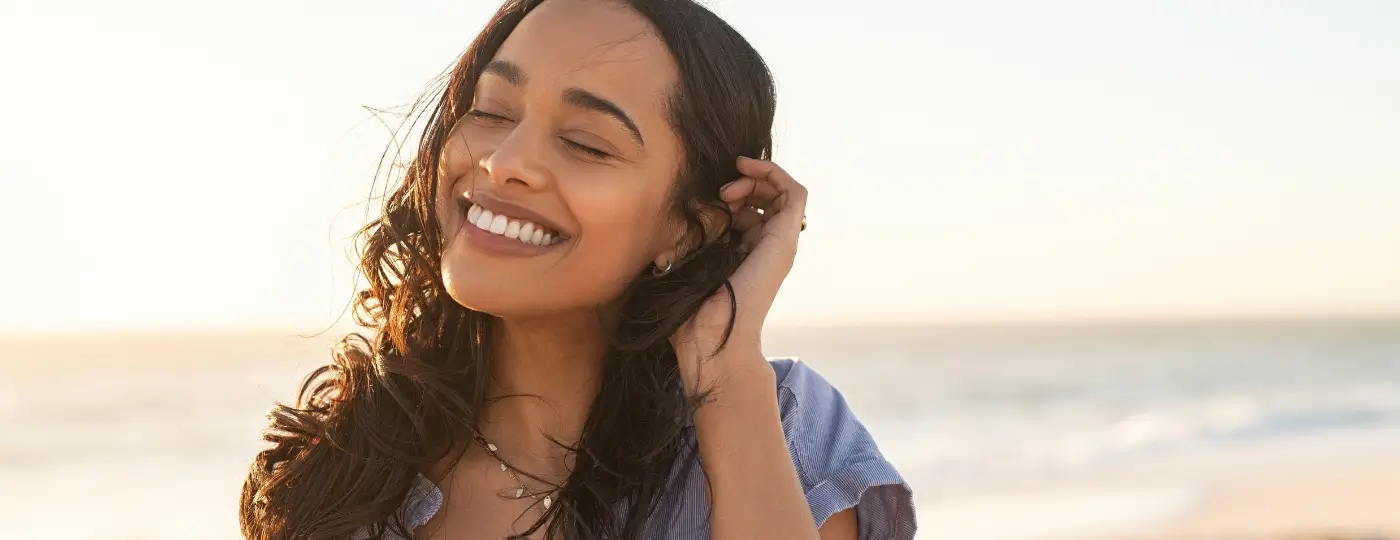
770,360,916,540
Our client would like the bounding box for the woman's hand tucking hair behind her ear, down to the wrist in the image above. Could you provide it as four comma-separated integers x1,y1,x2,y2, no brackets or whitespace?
671,158,806,390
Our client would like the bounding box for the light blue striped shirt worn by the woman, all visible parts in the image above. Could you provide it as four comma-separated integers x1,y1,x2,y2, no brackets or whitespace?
361,360,914,540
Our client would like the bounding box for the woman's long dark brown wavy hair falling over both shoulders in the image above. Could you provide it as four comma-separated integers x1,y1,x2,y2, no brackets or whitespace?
239,0,776,540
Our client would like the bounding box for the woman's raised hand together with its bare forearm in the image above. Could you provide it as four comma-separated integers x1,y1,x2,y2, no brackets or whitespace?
671,158,823,540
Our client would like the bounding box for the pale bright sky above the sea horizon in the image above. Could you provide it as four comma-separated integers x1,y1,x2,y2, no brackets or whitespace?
0,0,1400,332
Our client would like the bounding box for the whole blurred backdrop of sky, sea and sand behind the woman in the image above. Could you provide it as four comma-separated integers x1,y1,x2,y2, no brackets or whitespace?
0,0,1400,540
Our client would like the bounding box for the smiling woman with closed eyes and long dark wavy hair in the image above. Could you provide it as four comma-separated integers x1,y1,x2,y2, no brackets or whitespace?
241,0,914,540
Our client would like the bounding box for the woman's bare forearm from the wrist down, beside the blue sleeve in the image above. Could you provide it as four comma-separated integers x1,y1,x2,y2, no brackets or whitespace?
694,351,818,540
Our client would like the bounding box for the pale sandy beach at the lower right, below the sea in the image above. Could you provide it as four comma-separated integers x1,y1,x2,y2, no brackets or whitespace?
916,428,1400,540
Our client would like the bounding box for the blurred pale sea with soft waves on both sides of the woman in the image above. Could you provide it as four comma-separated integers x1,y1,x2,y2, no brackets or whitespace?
0,319,1400,540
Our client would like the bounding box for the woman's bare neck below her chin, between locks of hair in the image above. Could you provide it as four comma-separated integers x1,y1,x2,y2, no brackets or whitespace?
480,311,606,471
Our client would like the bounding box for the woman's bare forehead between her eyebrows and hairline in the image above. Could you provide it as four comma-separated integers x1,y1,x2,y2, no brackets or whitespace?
494,0,676,116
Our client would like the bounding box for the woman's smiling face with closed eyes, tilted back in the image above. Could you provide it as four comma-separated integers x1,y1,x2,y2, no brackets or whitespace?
437,0,683,316
